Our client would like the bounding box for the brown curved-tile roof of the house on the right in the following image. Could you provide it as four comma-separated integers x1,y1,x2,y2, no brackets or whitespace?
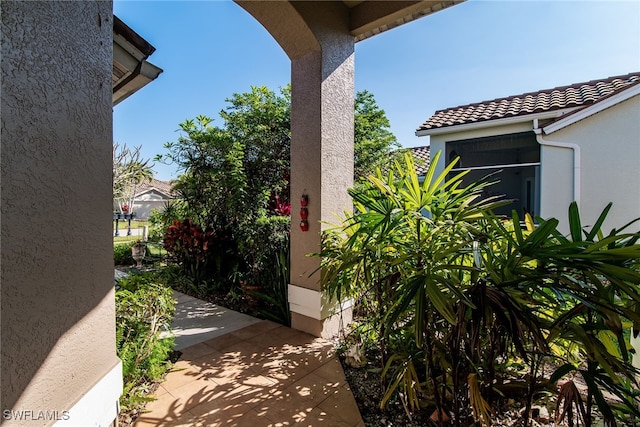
417,72,640,131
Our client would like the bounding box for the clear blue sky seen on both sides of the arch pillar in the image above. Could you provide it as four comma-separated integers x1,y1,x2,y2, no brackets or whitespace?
113,0,640,180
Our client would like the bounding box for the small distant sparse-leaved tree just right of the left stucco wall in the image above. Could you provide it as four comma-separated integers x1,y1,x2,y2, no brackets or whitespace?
113,142,153,213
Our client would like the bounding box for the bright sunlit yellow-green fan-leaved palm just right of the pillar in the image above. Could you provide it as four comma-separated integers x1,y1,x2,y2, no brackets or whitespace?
320,153,505,424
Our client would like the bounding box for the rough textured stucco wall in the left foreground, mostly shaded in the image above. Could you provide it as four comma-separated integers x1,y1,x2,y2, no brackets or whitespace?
0,1,118,425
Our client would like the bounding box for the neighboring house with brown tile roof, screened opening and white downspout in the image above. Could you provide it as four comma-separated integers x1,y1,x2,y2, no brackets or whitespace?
416,72,640,231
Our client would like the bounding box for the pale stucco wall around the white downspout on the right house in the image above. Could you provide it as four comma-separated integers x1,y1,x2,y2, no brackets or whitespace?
542,96,640,232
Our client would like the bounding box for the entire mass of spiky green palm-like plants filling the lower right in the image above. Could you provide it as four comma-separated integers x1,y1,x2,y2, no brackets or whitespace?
317,154,640,426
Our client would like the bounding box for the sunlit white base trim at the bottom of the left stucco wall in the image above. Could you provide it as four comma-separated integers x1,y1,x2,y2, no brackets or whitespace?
54,360,123,427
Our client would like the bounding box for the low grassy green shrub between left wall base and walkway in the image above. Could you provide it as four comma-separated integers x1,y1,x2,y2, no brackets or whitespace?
116,273,175,412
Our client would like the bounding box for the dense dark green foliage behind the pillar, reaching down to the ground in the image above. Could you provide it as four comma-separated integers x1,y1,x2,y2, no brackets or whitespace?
151,87,398,323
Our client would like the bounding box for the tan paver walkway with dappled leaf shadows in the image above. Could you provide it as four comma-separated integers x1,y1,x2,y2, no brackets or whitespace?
135,294,364,427
